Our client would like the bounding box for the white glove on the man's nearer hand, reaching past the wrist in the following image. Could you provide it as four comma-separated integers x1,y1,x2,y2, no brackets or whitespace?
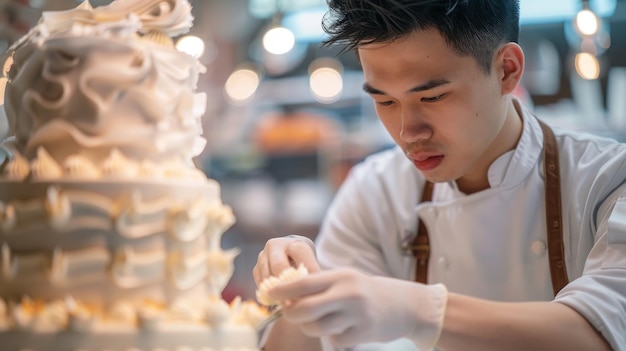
269,268,448,351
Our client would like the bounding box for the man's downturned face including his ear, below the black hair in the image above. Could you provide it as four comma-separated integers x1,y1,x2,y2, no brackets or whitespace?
358,30,523,191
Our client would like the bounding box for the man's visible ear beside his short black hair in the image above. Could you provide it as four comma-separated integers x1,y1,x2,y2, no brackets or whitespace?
494,42,524,95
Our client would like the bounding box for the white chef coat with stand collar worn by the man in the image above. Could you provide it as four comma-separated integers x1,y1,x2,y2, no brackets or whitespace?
316,101,626,350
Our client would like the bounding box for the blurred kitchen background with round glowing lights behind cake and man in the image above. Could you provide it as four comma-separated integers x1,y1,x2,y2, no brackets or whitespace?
0,0,626,299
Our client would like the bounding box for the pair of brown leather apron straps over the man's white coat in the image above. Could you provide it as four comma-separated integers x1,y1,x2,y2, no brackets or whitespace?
410,120,568,296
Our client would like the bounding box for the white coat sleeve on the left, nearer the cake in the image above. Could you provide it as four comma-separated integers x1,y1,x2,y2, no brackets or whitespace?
317,148,423,279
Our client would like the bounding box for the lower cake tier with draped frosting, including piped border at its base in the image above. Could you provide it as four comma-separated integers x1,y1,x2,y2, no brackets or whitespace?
0,178,266,351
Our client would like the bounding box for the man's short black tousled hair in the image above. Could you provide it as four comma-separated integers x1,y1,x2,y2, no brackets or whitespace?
322,0,519,73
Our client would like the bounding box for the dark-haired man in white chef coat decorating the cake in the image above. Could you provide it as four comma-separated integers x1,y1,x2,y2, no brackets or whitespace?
254,0,626,351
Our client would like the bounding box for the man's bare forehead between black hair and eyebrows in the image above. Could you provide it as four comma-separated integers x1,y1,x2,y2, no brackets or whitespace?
358,29,480,83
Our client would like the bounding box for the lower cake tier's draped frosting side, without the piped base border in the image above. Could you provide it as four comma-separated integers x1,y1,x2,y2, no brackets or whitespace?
0,179,237,305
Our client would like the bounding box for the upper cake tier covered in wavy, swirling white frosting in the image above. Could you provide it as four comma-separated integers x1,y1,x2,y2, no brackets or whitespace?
6,0,206,170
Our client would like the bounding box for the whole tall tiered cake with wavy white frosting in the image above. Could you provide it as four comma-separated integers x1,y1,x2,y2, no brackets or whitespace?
0,0,265,351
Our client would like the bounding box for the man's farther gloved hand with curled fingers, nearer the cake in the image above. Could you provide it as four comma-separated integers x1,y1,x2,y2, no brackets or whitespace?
252,235,320,286
